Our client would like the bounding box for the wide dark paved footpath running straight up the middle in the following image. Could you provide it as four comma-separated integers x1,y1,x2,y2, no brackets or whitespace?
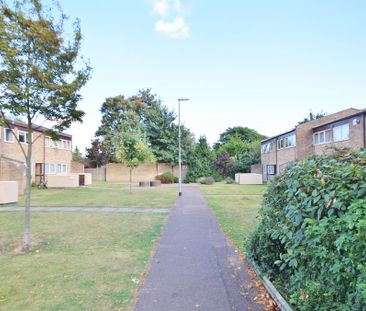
134,186,263,311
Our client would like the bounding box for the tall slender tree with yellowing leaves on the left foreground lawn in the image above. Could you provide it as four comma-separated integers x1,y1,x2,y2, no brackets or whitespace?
0,0,90,252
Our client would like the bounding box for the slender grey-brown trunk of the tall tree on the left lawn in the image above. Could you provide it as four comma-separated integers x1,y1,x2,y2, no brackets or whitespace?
22,134,32,253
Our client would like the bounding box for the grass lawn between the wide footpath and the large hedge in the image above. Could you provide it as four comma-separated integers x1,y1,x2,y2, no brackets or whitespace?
200,183,266,253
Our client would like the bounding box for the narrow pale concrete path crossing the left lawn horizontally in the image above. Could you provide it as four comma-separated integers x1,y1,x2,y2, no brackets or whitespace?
0,207,171,214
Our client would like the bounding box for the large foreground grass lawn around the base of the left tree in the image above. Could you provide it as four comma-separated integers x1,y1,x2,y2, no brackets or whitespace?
0,213,167,311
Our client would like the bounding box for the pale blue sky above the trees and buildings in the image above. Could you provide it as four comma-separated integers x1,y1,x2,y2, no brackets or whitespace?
54,0,366,150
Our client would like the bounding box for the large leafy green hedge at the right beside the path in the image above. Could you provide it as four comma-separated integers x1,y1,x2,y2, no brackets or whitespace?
248,150,366,310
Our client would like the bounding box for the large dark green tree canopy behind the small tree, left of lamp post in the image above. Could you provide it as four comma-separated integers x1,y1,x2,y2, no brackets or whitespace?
96,89,194,165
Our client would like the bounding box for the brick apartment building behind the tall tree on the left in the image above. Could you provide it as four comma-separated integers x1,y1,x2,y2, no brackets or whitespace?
0,121,72,190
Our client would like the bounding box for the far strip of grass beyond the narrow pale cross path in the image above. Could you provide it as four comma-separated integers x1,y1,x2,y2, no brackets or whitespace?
6,182,177,208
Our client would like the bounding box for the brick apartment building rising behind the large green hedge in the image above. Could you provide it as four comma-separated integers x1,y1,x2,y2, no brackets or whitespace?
261,108,366,181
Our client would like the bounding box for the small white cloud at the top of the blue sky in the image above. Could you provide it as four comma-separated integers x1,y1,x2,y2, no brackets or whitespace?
151,0,190,38
